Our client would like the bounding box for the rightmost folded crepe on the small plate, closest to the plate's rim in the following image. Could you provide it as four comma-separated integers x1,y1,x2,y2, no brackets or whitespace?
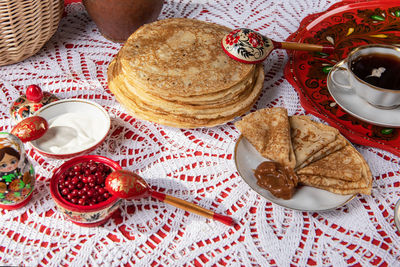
296,144,372,195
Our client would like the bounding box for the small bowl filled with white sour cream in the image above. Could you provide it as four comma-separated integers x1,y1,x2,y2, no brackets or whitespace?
30,99,111,159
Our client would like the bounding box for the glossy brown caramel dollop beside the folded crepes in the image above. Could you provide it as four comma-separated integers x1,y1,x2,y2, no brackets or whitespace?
254,161,298,199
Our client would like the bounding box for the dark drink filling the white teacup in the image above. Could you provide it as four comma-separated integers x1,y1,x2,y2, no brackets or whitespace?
350,53,400,90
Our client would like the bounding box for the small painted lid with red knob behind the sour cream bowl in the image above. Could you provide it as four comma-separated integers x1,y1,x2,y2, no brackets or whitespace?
10,84,59,123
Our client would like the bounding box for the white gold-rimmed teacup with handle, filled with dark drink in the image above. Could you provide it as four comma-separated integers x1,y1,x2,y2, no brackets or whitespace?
329,44,400,109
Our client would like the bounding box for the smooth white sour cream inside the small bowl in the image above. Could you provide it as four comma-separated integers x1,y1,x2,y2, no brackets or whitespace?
35,112,103,154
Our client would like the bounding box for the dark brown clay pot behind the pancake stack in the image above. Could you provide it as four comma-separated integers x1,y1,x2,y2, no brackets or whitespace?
82,0,163,42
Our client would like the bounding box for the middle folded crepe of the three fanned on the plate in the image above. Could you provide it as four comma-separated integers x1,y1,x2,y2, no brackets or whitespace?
289,115,346,169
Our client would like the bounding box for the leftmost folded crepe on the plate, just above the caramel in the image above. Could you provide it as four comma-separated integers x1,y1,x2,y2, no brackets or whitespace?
235,108,296,168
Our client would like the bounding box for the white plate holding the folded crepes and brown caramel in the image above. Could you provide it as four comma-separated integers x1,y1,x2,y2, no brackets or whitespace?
235,136,355,211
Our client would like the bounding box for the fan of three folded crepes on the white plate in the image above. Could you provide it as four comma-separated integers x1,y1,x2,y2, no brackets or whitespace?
235,108,372,195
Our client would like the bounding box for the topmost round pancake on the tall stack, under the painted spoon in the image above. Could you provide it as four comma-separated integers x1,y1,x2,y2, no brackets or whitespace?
119,18,255,97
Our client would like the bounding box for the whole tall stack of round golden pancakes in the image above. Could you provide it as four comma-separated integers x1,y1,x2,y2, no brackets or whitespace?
108,18,264,128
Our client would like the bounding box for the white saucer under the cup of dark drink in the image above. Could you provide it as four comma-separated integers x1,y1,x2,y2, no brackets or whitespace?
327,72,400,128
